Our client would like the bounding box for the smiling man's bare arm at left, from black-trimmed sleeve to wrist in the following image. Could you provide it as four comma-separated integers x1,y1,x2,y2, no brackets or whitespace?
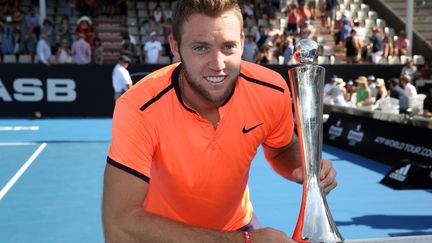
102,164,244,243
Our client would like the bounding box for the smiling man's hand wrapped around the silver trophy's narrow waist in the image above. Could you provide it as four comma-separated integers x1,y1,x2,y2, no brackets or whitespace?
292,159,337,194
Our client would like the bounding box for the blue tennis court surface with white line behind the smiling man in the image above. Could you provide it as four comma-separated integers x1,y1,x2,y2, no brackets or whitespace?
0,119,432,243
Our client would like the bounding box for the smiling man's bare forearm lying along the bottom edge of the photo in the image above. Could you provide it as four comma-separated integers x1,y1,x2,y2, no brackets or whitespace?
104,208,244,243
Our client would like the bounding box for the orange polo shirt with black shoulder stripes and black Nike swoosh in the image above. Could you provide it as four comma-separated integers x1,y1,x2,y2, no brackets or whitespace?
107,62,293,230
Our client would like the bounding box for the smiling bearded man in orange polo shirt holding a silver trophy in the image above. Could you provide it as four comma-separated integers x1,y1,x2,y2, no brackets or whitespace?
103,0,336,242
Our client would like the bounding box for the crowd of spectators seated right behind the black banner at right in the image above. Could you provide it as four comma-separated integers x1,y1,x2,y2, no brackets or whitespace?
323,57,432,117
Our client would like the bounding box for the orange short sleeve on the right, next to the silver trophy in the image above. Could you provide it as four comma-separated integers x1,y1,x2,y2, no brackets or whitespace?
264,81,294,148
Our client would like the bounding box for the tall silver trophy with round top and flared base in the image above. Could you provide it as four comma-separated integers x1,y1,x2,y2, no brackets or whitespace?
288,39,343,243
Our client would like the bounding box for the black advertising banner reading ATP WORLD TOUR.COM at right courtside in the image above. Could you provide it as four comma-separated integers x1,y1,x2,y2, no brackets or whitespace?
323,112,432,166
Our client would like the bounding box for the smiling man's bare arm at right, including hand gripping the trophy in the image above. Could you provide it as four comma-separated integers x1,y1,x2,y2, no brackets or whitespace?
263,134,337,193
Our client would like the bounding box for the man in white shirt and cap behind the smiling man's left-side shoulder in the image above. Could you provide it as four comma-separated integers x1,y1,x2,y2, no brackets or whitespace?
112,55,132,100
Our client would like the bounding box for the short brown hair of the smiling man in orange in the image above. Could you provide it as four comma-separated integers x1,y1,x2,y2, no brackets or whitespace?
172,0,243,44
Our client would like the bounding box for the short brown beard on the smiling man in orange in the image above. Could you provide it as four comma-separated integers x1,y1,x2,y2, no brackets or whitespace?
180,55,240,102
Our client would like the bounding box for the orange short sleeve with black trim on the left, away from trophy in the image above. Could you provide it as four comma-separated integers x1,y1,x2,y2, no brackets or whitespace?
107,98,156,182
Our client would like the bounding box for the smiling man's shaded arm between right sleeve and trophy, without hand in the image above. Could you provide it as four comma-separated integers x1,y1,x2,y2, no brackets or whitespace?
263,134,302,183
